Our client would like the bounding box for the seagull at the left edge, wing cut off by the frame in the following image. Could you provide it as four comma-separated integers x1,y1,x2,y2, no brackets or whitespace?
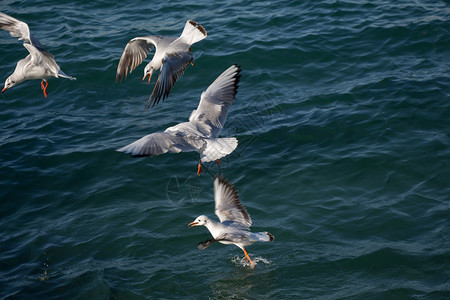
0,12,76,98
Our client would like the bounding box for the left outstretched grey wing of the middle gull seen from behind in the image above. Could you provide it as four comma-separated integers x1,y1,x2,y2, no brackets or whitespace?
117,131,204,157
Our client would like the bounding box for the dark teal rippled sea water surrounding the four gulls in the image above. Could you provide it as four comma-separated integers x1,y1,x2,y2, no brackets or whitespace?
0,0,450,299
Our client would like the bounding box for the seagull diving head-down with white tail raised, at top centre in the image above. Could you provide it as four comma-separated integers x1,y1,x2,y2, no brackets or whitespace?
116,20,207,109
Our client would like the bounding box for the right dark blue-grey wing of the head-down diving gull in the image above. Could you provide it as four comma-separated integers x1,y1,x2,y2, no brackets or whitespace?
147,51,194,109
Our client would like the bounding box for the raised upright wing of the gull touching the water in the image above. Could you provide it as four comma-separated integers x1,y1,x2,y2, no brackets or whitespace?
214,177,252,227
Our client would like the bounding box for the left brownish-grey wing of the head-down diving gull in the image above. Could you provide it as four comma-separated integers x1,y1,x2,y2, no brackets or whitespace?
116,36,162,81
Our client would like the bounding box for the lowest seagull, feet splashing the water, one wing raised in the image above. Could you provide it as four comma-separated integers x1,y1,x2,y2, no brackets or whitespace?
188,176,275,269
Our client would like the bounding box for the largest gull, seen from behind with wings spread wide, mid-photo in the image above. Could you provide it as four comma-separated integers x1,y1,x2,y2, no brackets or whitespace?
117,65,241,175
